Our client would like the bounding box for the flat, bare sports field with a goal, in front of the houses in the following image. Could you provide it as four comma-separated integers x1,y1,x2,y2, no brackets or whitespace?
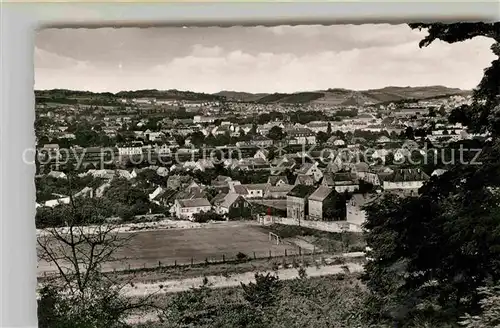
39,223,297,273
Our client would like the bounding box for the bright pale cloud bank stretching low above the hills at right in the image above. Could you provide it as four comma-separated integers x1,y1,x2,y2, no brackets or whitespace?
146,39,493,92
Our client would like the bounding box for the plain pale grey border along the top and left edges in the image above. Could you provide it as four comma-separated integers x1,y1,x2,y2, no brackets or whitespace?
0,1,500,328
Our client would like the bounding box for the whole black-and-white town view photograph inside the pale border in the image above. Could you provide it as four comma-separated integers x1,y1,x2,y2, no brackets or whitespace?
33,22,500,328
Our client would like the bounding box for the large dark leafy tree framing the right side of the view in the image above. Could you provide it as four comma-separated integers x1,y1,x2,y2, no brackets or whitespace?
365,23,500,326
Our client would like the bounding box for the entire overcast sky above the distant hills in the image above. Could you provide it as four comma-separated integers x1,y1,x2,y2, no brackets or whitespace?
35,24,494,93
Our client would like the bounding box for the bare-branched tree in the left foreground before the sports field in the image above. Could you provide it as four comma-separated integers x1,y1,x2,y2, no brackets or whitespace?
37,179,162,328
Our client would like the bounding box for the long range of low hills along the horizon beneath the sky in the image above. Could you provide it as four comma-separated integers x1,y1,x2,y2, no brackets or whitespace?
35,86,471,106
